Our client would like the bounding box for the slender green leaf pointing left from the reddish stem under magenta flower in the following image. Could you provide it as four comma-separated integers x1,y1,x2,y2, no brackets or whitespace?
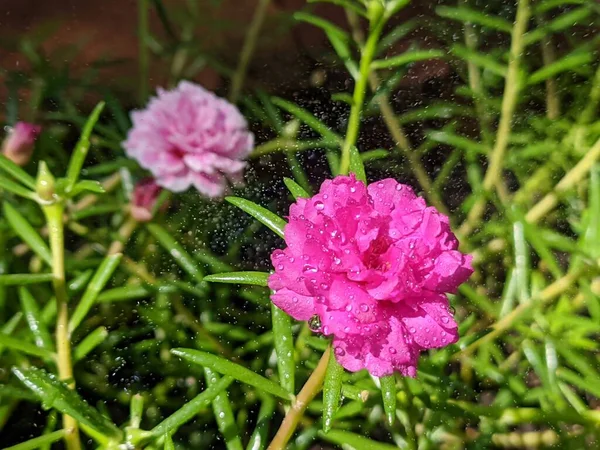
171,348,293,400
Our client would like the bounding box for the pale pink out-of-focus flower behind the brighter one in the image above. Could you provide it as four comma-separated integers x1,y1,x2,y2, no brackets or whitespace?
123,81,254,197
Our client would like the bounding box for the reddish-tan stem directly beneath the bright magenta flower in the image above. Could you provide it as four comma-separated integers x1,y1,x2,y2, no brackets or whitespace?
267,347,331,450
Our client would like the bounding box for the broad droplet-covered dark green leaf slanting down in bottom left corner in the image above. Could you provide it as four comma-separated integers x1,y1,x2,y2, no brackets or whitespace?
12,367,121,439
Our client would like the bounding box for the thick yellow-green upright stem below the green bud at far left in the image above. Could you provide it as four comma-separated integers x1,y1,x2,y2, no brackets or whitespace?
43,202,81,450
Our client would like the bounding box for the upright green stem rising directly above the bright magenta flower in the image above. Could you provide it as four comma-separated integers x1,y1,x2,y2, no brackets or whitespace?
339,19,385,175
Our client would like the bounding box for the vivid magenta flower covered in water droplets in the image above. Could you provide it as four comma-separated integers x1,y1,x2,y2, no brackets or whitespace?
269,175,473,377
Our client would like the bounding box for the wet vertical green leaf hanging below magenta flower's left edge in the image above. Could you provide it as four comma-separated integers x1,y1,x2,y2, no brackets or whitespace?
271,303,296,393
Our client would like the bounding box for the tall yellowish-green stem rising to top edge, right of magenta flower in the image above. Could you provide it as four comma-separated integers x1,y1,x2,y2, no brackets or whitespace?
459,0,530,236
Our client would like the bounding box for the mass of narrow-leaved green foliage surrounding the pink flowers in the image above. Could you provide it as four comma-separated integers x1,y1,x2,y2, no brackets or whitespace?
0,0,600,450
